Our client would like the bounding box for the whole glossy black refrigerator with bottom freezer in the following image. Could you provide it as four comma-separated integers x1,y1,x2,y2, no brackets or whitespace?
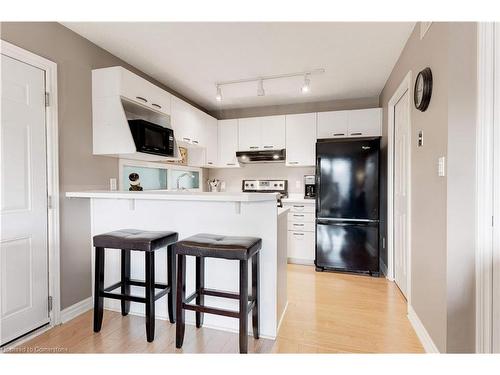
315,138,380,276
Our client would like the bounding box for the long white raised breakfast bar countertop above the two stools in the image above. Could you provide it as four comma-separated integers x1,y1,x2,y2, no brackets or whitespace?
66,190,277,202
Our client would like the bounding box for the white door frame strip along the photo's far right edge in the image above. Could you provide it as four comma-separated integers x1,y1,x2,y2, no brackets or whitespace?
475,22,500,353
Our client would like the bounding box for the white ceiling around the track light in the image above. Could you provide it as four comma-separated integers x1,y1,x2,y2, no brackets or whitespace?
64,22,414,110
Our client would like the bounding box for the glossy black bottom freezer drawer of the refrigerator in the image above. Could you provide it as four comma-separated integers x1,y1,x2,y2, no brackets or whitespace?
316,222,379,273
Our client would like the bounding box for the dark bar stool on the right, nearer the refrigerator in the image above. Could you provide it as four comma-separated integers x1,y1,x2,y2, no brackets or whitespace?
173,234,262,353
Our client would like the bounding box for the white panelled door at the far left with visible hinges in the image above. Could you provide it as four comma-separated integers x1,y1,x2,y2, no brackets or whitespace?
0,55,50,344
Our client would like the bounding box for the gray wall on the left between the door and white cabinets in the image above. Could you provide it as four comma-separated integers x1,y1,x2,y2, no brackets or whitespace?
0,22,205,309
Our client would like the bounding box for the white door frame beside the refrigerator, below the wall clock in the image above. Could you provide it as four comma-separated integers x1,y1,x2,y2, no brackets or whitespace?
386,70,413,306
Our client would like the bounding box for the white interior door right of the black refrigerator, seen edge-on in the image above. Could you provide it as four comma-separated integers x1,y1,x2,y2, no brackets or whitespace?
393,91,410,298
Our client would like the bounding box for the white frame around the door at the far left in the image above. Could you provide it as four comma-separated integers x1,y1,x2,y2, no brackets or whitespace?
0,40,61,329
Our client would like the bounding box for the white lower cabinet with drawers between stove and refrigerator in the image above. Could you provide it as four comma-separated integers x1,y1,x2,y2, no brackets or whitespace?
284,201,316,265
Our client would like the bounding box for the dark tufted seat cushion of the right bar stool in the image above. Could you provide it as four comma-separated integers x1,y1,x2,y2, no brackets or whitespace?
174,233,262,260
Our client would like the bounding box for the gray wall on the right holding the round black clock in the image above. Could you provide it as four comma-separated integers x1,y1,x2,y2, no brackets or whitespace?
380,23,476,352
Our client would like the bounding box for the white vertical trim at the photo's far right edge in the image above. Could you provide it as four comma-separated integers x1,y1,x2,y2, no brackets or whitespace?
475,23,500,353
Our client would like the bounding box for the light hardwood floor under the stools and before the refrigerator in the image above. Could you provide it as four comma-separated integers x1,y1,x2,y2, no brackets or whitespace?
11,265,423,353
